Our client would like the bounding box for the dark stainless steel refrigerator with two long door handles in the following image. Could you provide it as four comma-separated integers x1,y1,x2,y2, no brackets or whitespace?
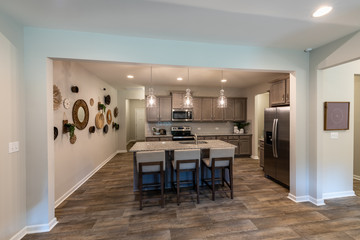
264,107,290,186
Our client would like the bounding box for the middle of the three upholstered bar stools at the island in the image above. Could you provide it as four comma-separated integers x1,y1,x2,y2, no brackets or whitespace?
171,149,200,205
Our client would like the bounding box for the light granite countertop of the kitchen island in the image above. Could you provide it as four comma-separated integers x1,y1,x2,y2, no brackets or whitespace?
129,140,236,152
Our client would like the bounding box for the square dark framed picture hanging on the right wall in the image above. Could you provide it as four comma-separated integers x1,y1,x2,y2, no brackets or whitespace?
324,102,350,131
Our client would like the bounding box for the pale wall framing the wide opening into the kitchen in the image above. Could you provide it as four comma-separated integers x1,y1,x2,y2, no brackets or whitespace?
25,28,309,227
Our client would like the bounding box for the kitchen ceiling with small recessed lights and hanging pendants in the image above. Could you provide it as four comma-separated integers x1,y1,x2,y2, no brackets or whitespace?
71,60,289,89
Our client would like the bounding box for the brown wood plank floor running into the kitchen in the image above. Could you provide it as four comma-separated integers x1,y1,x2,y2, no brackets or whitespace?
23,153,360,240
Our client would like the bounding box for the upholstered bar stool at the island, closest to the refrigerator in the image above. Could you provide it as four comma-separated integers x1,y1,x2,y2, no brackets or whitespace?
201,147,235,201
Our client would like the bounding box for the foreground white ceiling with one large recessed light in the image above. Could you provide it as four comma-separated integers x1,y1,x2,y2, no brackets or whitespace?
0,0,360,50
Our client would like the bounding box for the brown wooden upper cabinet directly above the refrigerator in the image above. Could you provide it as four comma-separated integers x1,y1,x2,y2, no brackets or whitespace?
270,78,290,106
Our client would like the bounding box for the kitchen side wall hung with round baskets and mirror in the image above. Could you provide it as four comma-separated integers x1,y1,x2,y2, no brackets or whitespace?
53,60,119,204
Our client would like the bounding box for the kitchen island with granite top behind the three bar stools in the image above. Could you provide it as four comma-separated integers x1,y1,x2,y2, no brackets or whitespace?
129,140,237,191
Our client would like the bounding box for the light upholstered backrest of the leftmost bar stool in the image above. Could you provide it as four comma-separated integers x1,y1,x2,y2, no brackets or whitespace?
136,150,165,172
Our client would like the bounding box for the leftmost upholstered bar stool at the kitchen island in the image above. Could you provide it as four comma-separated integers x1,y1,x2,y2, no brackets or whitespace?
136,151,165,210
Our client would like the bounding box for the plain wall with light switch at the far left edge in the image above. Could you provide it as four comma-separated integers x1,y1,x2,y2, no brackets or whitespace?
0,15,26,240
